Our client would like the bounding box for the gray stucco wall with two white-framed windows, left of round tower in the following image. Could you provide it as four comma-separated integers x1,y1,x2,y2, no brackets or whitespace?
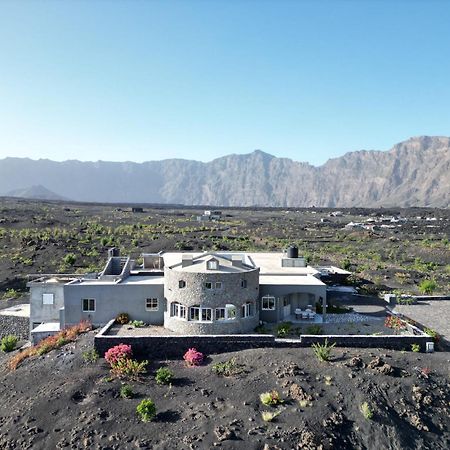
62,284,165,325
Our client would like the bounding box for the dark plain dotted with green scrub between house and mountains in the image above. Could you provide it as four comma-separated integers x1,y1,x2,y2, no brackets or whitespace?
0,199,450,299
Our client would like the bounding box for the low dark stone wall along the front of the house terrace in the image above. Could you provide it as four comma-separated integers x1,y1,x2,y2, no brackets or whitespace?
94,321,432,360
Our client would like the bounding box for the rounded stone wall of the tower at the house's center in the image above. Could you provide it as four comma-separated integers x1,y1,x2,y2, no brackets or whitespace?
164,268,259,334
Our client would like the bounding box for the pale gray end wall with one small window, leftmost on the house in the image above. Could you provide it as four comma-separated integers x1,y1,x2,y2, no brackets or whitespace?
29,283,64,331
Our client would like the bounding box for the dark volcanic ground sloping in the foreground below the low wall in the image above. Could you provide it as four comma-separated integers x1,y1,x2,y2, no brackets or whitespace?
0,332,450,450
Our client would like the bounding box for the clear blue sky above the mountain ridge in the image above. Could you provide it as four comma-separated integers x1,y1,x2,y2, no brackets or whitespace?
0,0,450,165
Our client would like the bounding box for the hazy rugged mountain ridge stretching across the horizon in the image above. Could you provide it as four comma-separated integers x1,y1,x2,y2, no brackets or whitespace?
0,136,450,207
